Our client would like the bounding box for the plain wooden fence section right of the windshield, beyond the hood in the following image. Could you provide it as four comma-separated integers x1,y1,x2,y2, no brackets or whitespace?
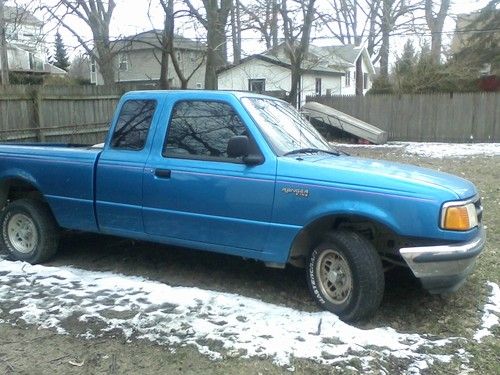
308,93,500,143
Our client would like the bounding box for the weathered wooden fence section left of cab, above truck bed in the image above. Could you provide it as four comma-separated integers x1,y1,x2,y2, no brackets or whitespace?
0,86,150,144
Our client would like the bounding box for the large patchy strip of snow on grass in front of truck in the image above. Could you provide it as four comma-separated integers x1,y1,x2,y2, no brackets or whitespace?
0,259,467,374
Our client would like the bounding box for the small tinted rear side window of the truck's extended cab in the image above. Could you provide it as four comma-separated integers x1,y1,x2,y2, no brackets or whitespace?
111,100,156,151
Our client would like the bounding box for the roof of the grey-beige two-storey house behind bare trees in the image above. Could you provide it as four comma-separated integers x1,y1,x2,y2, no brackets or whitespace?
116,30,206,51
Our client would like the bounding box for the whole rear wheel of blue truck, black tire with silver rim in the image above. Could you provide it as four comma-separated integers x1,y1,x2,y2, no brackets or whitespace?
0,199,59,264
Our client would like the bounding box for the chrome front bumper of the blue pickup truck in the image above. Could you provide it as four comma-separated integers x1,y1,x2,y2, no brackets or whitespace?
399,227,486,294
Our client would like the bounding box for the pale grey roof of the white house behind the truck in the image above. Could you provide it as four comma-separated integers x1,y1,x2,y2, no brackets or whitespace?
221,43,375,75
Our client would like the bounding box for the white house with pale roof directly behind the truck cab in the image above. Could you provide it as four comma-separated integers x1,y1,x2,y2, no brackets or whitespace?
218,44,375,104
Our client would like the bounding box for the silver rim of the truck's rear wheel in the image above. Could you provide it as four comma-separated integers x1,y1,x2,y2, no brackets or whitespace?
7,214,38,254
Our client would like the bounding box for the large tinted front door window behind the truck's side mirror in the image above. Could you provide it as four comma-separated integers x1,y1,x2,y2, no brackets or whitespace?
163,101,247,160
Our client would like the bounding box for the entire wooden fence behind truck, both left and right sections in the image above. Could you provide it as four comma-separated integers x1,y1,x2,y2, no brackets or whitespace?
0,86,500,144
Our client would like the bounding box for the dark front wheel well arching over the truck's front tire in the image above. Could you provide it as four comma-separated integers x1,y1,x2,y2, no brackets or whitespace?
288,215,403,267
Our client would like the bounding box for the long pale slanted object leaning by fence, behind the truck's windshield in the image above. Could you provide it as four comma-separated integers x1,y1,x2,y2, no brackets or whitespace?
302,102,387,145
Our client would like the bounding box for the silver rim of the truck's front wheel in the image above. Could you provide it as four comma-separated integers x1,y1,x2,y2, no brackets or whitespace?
316,250,352,304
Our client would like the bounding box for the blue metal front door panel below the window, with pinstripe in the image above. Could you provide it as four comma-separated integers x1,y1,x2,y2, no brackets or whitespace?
144,157,275,251
